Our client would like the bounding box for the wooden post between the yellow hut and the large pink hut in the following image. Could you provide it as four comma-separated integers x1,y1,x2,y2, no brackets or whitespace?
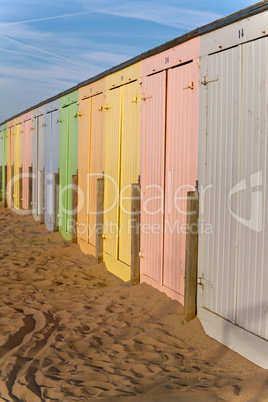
131,184,141,285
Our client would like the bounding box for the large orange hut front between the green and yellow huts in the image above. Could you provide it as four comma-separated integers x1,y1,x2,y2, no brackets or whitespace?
77,80,105,255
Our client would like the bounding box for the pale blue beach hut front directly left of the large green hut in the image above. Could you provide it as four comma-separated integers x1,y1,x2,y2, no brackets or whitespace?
44,99,60,230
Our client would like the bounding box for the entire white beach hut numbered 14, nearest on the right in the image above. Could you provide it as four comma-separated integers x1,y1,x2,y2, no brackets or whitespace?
197,2,268,369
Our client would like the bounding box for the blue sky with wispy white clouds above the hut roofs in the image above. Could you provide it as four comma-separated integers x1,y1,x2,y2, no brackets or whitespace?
0,0,254,122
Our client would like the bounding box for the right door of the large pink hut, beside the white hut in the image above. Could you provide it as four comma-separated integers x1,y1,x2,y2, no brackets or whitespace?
163,62,198,296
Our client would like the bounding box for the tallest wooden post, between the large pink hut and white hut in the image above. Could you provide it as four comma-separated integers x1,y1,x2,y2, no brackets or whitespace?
184,191,199,321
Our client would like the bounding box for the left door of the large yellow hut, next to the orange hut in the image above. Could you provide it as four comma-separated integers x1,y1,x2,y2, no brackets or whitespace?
104,87,122,259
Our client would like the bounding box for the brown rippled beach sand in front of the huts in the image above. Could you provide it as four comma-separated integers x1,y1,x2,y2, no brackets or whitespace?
0,208,268,402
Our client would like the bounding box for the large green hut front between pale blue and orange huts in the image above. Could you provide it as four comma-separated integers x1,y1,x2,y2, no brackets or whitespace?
59,91,79,240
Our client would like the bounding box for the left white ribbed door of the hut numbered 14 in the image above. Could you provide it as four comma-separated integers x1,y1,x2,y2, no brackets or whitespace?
201,47,241,321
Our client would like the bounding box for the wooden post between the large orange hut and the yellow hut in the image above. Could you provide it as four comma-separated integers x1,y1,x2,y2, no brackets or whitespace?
96,178,104,264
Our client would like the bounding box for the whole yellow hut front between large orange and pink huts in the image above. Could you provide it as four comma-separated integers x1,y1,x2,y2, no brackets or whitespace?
103,63,141,281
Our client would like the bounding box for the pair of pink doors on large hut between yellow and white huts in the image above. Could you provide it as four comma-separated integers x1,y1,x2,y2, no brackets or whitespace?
141,62,199,303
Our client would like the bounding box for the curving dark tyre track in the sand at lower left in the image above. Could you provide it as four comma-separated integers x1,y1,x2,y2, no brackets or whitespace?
0,308,58,402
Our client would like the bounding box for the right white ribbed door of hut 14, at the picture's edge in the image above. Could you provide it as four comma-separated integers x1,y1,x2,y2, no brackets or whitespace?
237,37,268,339
